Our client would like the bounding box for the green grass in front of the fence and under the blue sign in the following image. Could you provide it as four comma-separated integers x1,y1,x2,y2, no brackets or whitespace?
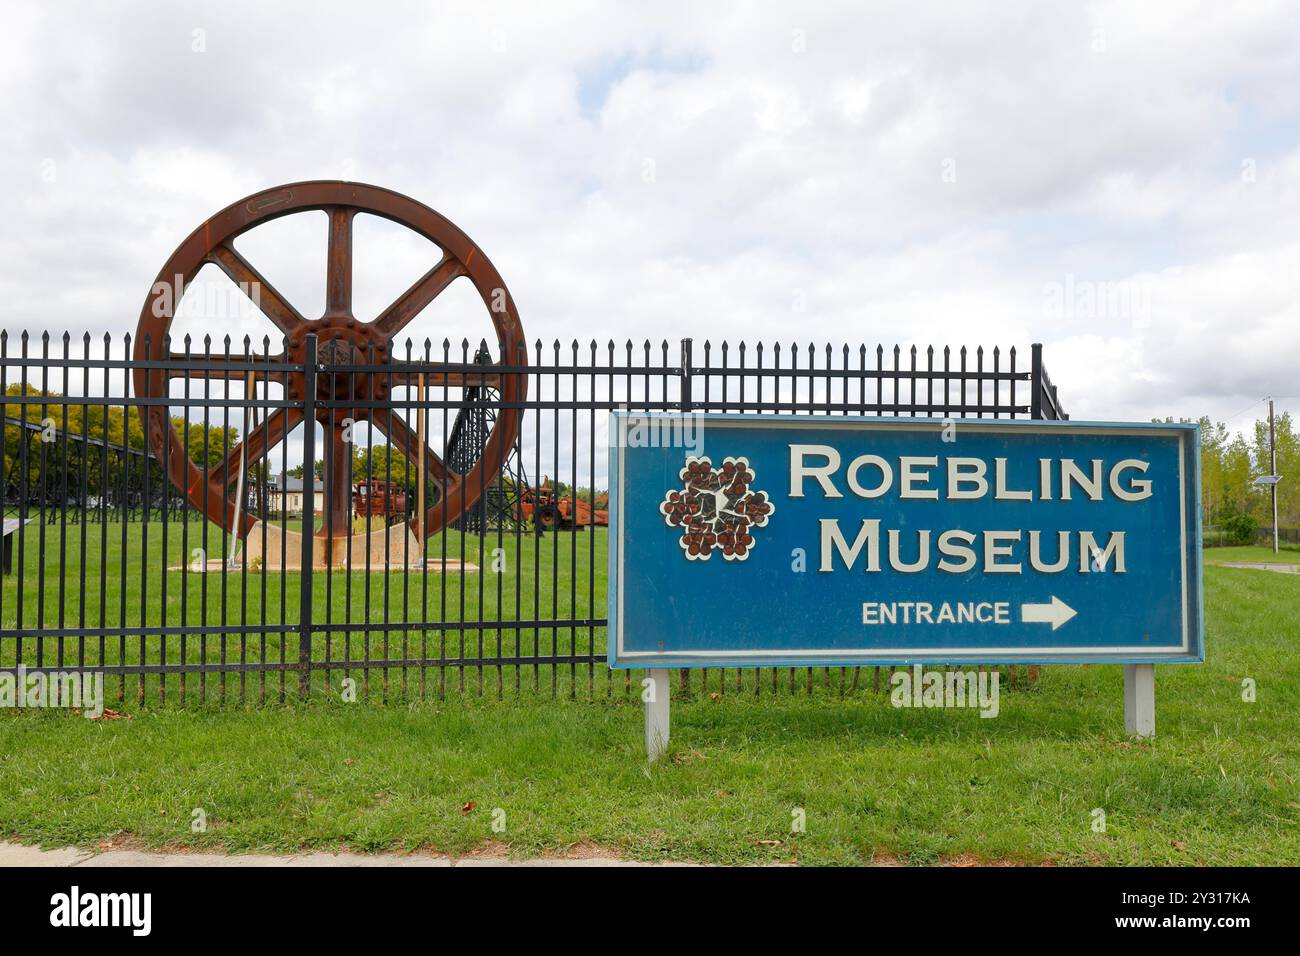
0,549,1300,865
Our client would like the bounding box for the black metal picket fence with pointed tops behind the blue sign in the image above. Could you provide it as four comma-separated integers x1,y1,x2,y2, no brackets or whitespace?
0,333,1065,702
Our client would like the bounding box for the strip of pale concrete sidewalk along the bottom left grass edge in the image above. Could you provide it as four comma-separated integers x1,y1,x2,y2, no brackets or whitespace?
0,843,694,866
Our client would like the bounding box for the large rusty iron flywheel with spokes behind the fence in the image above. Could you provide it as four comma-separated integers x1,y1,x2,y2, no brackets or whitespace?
134,181,528,540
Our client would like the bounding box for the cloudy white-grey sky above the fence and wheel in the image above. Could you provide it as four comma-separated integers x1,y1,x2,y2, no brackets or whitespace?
0,0,1300,442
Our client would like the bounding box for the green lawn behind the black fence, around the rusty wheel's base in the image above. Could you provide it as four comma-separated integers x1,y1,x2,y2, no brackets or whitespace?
0,519,607,701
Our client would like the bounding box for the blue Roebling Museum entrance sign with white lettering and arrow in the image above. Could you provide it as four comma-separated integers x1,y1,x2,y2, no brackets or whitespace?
608,412,1204,669
